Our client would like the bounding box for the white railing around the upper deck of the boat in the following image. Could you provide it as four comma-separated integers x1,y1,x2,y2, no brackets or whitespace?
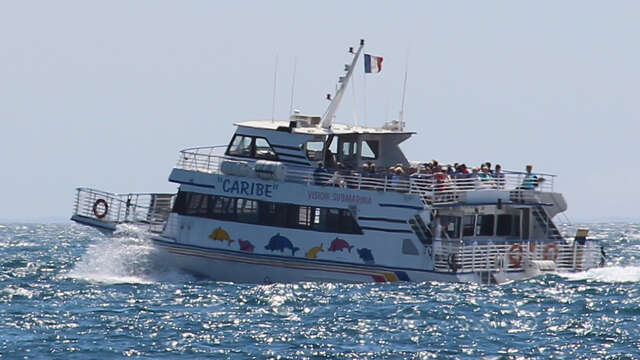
176,146,555,205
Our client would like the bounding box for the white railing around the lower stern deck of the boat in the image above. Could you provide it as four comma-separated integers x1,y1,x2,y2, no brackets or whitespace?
434,240,601,272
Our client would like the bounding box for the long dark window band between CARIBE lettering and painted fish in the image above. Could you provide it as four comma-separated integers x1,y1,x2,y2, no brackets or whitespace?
173,191,362,234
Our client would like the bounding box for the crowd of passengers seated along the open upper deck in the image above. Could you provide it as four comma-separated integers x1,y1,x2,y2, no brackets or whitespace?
314,160,544,191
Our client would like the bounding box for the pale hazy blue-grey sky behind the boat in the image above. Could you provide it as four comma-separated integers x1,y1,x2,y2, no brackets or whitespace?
0,1,640,220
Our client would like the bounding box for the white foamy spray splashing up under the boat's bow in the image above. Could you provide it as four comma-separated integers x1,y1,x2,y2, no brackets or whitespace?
68,225,193,284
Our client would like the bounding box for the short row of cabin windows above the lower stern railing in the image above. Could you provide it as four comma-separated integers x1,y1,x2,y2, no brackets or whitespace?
440,214,520,239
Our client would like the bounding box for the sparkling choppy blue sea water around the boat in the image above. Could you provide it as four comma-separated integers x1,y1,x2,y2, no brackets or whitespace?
0,223,640,359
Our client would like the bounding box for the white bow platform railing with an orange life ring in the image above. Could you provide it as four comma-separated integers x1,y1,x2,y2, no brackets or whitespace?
74,188,175,230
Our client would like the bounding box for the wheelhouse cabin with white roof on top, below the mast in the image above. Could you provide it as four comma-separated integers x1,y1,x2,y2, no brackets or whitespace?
226,113,414,170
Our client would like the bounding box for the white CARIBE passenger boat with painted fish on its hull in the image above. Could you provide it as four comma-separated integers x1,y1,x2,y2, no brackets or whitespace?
71,41,604,284
